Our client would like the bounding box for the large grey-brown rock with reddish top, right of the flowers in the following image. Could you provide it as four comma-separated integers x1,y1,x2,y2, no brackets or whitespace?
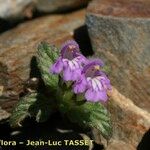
86,0,150,112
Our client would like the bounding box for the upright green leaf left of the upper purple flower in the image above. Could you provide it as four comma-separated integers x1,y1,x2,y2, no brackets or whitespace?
37,42,59,89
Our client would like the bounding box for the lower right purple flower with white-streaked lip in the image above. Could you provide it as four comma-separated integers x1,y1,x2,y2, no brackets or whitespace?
73,59,111,102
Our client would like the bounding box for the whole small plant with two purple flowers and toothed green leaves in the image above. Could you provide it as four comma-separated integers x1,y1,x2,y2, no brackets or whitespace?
10,40,112,138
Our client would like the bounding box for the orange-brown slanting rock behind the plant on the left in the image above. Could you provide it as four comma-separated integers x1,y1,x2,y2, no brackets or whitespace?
0,10,85,112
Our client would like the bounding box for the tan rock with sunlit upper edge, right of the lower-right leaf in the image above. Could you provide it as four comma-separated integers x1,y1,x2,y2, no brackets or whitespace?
108,88,150,148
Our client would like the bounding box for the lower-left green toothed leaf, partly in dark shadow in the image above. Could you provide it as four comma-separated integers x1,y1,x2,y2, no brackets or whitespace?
9,93,54,127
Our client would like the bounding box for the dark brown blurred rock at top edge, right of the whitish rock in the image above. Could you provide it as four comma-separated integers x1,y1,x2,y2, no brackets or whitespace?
36,0,89,12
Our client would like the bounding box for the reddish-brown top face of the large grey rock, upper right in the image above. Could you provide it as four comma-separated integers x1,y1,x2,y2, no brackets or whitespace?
88,0,150,18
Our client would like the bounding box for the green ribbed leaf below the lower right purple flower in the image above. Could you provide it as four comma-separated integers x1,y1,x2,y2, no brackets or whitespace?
67,102,112,138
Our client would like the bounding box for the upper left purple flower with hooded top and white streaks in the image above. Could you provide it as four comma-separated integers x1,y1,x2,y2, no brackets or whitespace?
51,40,87,81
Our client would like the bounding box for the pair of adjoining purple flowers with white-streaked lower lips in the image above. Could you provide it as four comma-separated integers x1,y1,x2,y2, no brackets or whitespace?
51,40,111,102
